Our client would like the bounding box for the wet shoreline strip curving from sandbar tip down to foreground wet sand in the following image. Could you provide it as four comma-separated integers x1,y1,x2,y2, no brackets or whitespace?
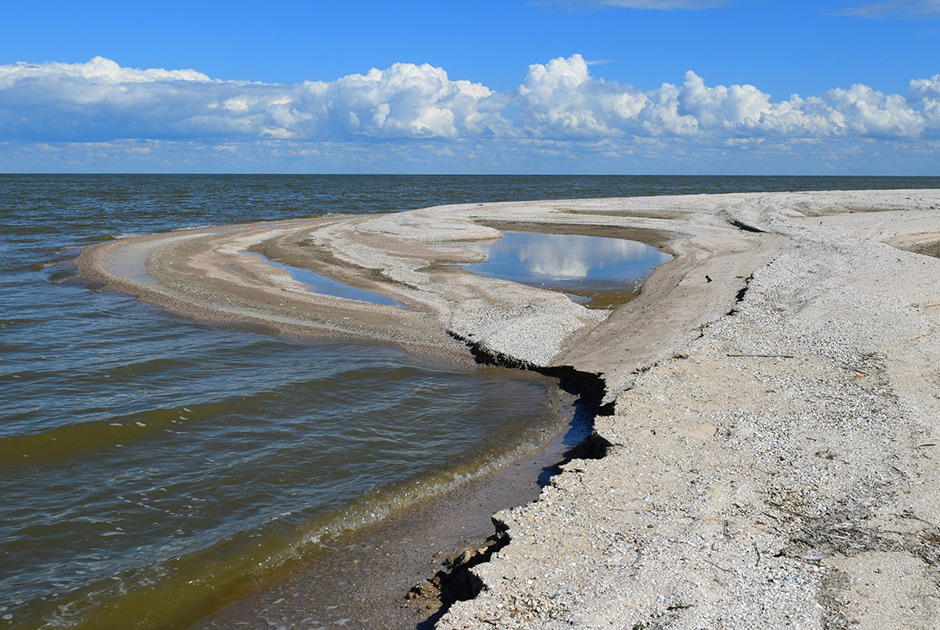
78,216,616,630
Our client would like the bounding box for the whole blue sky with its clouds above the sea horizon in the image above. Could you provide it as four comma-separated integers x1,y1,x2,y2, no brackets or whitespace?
0,0,940,175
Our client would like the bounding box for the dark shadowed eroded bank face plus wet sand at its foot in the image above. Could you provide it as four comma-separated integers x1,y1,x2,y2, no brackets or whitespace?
191,344,611,630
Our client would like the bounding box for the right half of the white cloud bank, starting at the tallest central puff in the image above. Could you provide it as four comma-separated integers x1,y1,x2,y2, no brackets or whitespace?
517,55,938,138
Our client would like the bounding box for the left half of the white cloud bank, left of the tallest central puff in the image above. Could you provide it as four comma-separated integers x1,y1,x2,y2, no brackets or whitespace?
0,57,507,141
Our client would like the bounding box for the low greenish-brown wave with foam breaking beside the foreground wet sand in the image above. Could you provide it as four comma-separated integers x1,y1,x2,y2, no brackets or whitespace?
5,390,567,630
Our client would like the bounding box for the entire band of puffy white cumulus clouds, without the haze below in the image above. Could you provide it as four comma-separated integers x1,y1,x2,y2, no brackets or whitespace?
0,54,940,154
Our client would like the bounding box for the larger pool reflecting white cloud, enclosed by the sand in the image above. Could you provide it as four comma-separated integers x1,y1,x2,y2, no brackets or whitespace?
461,232,672,308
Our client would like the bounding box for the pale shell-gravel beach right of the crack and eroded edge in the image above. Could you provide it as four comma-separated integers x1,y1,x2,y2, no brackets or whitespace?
438,193,940,629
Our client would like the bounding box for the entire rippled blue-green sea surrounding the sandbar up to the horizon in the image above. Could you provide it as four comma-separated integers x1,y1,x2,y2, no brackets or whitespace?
0,174,940,630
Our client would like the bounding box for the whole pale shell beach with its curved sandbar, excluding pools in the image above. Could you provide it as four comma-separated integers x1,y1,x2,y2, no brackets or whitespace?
79,190,940,628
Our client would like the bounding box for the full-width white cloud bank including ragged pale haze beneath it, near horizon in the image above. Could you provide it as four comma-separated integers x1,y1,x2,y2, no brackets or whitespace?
0,53,940,172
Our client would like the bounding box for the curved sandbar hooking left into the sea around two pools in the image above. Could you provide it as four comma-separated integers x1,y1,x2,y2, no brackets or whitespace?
79,198,761,379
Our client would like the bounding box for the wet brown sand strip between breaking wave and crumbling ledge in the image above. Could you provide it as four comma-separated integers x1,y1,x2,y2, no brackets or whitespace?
192,390,584,630
